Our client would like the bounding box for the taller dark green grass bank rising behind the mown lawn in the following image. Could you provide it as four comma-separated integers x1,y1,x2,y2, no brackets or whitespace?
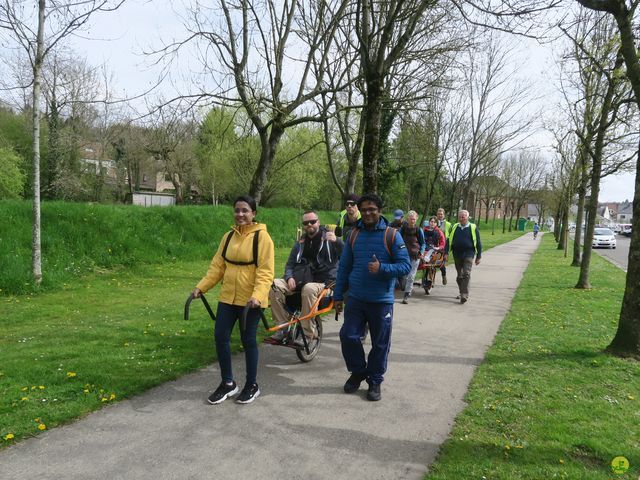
0,201,337,294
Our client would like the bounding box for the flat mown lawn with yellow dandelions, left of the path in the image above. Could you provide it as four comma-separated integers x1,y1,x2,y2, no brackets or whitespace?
0,229,514,448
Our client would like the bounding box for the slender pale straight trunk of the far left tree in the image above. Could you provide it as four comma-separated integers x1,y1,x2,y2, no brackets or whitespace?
31,0,45,285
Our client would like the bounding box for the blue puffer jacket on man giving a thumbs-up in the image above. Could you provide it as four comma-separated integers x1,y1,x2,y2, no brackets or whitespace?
333,217,411,303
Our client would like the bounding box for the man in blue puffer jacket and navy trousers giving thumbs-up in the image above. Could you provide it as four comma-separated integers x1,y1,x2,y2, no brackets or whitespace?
333,194,411,401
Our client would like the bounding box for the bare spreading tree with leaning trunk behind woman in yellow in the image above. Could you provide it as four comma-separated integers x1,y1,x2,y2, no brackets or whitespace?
157,0,348,201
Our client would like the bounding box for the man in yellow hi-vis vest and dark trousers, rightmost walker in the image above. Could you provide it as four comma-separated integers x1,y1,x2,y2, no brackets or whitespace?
445,210,482,303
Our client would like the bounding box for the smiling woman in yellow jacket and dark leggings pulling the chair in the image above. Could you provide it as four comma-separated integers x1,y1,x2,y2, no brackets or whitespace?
193,196,275,405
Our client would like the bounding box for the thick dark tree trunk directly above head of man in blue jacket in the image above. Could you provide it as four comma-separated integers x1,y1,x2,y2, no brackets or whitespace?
362,77,383,193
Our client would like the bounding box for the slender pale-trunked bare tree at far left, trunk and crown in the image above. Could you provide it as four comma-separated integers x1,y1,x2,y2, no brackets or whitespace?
0,0,124,284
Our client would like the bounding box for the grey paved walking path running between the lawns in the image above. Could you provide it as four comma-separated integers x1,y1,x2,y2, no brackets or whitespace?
0,234,540,480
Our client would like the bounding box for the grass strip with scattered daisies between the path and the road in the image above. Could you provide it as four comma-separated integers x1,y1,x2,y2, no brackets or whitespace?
425,235,640,480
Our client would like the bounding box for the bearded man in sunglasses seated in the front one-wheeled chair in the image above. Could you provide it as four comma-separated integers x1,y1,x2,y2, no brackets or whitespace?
269,210,343,343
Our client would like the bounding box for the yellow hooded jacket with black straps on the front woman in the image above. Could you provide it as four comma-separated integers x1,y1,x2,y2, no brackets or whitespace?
196,223,275,308
